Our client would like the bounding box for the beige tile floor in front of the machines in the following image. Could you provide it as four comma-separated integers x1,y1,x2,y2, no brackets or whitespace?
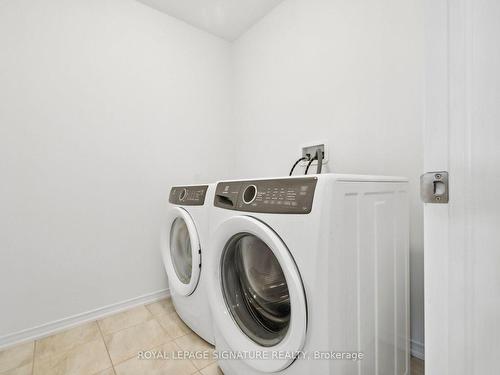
0,299,424,375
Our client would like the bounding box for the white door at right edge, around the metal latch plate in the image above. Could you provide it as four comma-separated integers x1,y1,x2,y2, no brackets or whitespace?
424,0,500,375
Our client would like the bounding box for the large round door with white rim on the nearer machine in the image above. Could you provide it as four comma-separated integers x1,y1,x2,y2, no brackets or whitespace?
210,216,307,372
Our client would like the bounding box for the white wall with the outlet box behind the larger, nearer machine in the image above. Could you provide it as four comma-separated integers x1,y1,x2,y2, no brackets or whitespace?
232,0,424,356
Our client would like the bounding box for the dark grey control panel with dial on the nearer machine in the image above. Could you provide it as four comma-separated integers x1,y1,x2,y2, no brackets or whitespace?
214,177,317,214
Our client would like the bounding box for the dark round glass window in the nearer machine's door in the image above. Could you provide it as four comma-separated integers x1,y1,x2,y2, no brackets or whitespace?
221,233,291,347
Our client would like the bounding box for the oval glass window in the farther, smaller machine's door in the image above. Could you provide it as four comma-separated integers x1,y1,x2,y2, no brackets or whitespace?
170,217,193,284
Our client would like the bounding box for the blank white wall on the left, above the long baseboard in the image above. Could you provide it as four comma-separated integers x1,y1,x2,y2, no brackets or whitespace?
0,0,230,341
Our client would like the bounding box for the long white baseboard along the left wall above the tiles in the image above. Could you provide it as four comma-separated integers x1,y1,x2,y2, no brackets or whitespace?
0,289,170,349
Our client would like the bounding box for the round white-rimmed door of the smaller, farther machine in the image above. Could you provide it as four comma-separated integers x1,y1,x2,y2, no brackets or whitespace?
162,207,201,296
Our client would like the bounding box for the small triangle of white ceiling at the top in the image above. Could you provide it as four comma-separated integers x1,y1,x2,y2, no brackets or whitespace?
139,0,283,41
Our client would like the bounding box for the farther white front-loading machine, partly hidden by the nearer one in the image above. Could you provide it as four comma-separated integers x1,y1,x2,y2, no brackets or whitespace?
161,184,215,344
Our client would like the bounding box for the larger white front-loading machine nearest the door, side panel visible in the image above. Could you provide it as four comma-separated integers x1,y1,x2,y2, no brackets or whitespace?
207,174,409,375
